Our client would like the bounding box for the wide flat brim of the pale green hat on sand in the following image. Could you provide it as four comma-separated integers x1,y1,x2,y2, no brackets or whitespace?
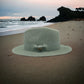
12,45,72,57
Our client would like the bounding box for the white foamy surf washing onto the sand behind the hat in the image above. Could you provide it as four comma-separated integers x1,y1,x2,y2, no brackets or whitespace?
0,21,52,36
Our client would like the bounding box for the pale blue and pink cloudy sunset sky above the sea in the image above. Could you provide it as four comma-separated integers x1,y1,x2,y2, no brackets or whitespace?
0,0,84,18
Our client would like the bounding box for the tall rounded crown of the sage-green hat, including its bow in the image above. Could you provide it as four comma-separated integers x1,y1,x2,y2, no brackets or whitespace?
24,27,60,51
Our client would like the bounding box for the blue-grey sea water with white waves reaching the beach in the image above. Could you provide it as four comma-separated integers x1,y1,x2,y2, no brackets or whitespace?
0,19,52,36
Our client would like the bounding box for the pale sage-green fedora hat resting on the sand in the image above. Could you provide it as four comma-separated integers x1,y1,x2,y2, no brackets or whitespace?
12,27,72,57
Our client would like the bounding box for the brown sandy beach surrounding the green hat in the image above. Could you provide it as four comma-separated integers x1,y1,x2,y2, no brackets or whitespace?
0,21,84,84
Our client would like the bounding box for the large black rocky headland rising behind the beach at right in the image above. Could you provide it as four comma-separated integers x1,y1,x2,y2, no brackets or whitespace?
47,6,84,22
